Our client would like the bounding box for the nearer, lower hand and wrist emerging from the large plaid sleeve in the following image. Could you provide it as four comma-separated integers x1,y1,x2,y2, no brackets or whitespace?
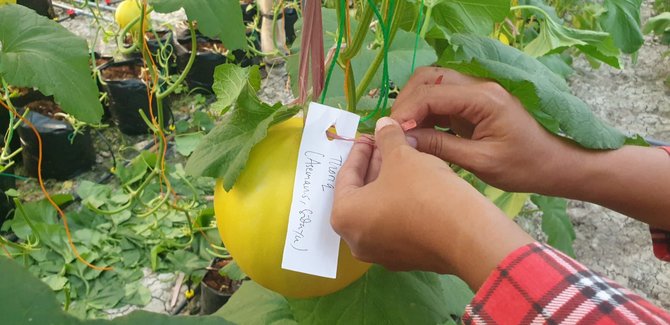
331,118,532,288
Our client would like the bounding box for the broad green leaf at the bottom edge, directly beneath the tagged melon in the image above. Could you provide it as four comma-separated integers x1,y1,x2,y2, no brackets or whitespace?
217,266,473,324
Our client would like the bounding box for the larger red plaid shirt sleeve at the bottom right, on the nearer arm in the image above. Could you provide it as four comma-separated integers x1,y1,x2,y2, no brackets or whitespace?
463,243,670,324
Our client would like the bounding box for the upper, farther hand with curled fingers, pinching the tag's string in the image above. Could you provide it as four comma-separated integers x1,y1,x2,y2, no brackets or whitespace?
391,67,584,194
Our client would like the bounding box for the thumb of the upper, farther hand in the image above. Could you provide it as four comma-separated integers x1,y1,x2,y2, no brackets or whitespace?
408,129,482,170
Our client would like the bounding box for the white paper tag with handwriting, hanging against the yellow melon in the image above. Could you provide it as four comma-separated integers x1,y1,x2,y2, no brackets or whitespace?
282,103,359,279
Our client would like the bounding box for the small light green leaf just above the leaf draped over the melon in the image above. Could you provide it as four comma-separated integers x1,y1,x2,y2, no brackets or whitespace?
212,64,260,111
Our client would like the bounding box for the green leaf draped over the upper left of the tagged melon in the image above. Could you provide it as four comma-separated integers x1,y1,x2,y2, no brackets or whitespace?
186,65,299,186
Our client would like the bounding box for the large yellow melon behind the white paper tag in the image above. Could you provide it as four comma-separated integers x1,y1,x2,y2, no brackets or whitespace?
214,118,370,298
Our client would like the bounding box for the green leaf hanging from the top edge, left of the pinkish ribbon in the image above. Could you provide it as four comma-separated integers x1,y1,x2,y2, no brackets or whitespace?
149,0,247,50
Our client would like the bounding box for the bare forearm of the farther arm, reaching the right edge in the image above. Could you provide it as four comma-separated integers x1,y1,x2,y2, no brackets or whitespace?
542,146,670,230
